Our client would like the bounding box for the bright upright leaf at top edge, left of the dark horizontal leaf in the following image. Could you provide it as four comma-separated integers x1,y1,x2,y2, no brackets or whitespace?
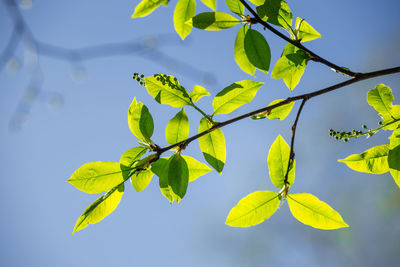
174,0,196,40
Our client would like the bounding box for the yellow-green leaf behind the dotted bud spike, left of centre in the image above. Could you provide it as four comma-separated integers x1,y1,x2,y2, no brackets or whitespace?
145,74,191,108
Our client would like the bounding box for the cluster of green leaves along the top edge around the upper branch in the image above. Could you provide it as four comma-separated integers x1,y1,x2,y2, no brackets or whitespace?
132,0,321,90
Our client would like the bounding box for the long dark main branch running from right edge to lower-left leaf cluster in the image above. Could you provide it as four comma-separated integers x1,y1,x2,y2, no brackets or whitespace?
157,67,400,155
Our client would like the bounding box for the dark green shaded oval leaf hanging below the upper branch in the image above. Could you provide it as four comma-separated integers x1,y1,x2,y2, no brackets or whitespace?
244,29,271,73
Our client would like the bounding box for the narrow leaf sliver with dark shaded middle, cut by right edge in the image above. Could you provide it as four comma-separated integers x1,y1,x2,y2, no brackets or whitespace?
388,128,400,187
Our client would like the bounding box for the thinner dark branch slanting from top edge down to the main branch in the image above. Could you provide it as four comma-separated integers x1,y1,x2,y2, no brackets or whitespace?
240,0,359,77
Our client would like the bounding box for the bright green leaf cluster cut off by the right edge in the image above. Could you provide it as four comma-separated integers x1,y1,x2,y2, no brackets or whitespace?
339,84,400,187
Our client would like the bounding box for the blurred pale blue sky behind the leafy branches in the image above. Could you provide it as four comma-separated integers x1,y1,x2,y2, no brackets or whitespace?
0,0,400,267
